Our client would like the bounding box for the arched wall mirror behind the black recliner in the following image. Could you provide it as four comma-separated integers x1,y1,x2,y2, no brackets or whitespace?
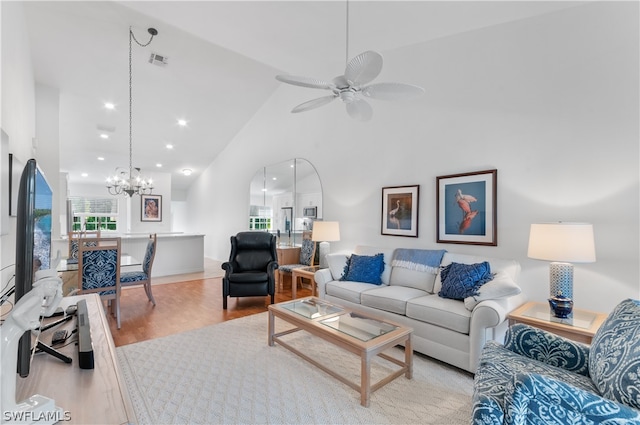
249,158,322,246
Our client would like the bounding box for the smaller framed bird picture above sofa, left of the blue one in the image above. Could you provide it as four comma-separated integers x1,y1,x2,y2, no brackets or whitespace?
381,185,420,238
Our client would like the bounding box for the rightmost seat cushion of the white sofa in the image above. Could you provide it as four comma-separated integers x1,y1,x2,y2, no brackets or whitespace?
406,295,471,334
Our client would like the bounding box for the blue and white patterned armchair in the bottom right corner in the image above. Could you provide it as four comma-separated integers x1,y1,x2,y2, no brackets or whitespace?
472,299,640,425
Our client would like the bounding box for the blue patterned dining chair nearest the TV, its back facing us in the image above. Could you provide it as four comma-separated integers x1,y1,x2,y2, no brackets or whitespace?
78,238,121,329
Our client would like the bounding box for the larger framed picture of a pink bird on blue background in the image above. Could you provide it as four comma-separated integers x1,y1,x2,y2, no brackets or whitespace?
436,170,498,246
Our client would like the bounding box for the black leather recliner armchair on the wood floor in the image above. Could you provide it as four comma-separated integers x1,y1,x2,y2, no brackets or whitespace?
222,232,278,309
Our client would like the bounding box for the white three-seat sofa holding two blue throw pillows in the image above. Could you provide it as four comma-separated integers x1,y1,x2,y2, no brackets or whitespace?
315,246,524,373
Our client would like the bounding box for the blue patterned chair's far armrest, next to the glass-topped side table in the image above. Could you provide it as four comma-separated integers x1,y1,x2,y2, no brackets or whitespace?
504,323,589,376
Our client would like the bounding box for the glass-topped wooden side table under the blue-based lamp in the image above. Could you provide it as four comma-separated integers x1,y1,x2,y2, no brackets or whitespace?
507,301,607,344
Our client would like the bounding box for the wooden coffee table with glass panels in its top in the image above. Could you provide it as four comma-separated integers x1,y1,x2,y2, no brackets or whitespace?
269,297,413,407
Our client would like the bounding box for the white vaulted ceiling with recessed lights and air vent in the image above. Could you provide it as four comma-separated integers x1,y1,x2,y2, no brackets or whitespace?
24,0,583,190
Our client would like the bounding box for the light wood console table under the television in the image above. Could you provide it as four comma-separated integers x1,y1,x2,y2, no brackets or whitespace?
15,294,137,424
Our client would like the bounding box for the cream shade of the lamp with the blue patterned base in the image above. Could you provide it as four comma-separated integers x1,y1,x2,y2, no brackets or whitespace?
527,222,596,263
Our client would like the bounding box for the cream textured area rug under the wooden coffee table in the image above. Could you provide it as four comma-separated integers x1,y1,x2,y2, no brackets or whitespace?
117,313,473,424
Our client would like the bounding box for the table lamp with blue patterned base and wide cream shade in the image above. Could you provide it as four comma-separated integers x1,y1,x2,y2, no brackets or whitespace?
527,222,596,317
